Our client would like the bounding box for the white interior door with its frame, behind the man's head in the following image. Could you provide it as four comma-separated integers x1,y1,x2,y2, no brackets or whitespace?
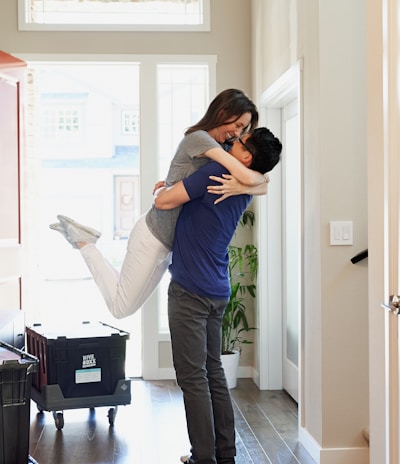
255,62,302,394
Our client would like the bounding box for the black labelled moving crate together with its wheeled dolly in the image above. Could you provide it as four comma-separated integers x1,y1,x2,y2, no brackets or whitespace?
26,322,131,429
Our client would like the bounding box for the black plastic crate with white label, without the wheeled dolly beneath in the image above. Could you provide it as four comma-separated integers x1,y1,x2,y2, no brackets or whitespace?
26,322,129,398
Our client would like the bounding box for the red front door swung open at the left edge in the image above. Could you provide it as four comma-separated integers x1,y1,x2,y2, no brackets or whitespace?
0,52,26,316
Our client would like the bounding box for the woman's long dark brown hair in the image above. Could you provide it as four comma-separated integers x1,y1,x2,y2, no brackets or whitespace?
185,89,258,135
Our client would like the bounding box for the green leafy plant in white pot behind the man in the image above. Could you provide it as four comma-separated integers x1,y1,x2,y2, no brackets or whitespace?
222,210,258,388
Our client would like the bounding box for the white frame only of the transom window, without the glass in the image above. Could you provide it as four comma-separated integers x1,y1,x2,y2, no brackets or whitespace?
18,0,211,32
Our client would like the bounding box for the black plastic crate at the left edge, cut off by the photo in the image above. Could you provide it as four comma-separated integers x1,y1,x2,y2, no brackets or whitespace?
0,341,38,464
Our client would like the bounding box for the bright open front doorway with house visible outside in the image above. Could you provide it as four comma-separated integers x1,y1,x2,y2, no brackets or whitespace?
23,59,142,376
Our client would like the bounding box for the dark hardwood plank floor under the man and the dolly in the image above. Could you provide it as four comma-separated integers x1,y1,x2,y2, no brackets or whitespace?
30,379,315,464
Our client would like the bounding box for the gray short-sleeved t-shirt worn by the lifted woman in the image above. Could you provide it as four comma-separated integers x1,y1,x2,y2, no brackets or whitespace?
146,131,221,250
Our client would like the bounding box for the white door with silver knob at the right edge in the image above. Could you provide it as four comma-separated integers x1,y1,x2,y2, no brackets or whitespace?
376,0,400,458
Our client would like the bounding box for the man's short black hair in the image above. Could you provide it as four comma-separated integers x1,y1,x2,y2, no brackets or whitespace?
246,127,282,174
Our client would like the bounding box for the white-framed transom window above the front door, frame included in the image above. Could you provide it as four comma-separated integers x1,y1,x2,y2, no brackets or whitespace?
18,0,210,32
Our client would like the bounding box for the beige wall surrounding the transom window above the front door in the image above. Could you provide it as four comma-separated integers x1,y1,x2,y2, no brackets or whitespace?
0,0,251,94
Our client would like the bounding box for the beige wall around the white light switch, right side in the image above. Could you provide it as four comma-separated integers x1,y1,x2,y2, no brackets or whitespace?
253,0,369,464
